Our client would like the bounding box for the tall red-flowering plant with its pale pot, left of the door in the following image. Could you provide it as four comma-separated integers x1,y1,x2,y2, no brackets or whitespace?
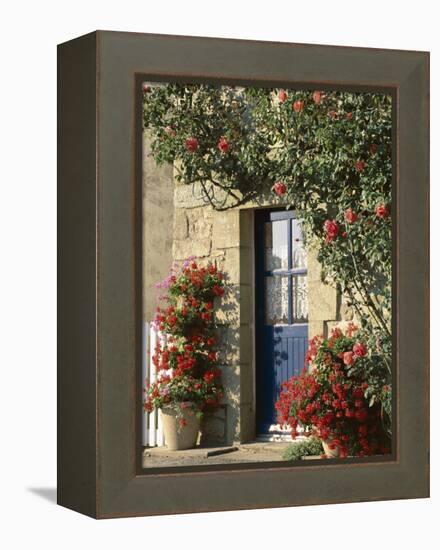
144,260,225,450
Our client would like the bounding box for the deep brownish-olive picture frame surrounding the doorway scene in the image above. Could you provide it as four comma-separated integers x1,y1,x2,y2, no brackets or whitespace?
58,31,429,518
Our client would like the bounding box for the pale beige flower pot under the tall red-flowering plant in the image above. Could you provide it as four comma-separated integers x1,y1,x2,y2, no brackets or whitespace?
161,407,200,451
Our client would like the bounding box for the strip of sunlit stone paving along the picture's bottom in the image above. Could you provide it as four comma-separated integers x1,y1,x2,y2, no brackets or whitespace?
143,442,296,468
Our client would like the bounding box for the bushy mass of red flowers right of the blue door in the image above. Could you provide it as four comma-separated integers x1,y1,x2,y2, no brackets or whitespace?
276,325,390,458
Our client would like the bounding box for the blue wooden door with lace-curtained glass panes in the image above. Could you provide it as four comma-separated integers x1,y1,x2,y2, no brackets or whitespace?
255,210,308,434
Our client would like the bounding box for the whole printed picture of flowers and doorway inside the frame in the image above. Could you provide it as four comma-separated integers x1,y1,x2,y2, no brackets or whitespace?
138,82,393,469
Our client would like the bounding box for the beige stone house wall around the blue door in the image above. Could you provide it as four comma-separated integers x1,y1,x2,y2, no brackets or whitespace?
144,135,352,445
